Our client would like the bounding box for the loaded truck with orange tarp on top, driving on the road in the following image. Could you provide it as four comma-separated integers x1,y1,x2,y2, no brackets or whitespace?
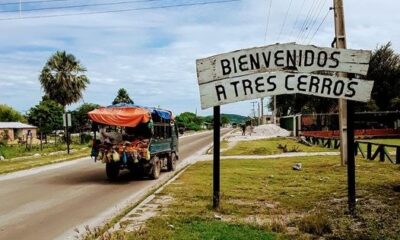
88,104,179,180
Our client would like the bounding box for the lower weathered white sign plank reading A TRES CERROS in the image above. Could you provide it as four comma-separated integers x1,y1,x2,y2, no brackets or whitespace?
200,72,373,109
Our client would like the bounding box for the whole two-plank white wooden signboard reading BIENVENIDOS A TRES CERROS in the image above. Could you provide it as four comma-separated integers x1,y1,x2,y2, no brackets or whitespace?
197,43,373,109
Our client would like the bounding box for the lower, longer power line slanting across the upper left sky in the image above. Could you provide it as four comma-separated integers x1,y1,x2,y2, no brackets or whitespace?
0,0,241,21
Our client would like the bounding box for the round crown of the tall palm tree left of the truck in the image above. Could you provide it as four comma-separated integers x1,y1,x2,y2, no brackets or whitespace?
39,51,90,109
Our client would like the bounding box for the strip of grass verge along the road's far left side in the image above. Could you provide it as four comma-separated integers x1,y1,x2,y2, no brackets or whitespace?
0,148,90,174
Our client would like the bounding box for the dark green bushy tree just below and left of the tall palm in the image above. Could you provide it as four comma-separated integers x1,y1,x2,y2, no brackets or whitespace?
27,96,64,134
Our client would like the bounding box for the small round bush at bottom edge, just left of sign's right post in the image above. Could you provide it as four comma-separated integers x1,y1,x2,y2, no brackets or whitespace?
298,213,332,235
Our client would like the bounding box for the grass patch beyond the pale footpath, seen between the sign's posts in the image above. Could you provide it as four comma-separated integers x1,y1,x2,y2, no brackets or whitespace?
222,138,335,156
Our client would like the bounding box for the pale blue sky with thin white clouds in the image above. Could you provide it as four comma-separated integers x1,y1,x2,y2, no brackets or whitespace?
0,0,400,116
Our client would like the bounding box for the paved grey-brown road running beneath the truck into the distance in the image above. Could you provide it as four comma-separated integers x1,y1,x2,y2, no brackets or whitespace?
0,130,227,240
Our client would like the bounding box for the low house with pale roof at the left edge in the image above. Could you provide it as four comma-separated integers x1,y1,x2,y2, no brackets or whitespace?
0,122,37,141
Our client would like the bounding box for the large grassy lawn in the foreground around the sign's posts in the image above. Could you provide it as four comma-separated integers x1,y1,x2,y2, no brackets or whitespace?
119,156,400,239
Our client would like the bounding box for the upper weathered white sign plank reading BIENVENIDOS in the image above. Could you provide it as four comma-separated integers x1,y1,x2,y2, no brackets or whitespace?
197,43,371,84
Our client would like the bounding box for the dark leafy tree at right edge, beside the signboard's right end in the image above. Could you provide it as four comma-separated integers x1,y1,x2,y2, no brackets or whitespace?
367,42,400,111
